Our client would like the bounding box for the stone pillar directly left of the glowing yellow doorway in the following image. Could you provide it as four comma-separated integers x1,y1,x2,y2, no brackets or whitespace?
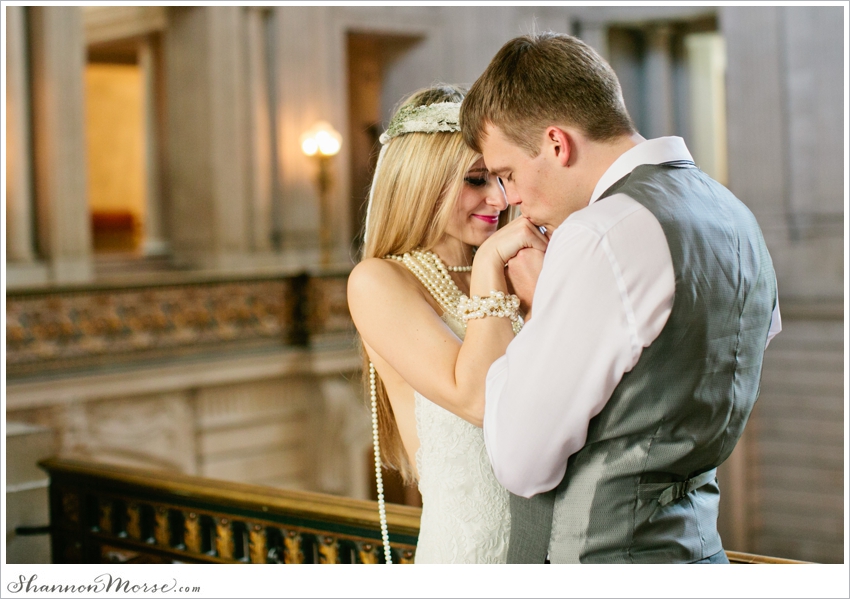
28,6,92,283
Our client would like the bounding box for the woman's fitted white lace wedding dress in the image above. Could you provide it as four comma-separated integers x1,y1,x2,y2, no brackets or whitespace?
415,312,510,564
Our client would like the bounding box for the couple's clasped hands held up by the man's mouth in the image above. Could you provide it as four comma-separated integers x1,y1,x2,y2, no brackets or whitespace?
478,217,549,321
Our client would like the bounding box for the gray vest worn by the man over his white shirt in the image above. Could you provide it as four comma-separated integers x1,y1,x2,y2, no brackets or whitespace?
508,162,776,563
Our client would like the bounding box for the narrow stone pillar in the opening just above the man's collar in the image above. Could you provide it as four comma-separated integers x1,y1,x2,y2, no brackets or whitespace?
642,26,674,138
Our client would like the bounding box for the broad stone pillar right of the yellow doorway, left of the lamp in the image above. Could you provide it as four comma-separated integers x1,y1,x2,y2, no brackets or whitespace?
165,7,249,268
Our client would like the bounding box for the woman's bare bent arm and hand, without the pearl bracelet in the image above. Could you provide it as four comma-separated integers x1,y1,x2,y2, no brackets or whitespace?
348,218,546,426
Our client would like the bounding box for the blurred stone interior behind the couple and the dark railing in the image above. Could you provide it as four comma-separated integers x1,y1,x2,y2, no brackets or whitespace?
4,6,846,562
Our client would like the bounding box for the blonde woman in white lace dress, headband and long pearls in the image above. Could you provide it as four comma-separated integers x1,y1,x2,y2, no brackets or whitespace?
348,85,546,563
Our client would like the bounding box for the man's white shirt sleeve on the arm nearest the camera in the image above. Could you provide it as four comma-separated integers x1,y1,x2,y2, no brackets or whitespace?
484,195,675,497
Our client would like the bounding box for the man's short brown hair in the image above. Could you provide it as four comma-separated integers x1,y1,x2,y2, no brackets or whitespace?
460,32,635,156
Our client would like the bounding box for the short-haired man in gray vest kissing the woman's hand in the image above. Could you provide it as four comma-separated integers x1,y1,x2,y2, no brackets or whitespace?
461,33,781,563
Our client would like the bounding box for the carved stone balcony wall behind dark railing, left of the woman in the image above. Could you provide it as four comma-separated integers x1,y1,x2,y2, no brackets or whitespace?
6,276,371,498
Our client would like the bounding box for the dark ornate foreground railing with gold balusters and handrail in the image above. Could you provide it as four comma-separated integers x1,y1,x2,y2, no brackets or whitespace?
40,459,803,564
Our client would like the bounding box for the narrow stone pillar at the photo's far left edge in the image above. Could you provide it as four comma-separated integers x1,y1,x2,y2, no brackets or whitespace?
6,6,34,263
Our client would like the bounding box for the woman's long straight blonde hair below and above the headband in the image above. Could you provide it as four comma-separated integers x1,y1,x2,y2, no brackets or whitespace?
362,85,481,483
